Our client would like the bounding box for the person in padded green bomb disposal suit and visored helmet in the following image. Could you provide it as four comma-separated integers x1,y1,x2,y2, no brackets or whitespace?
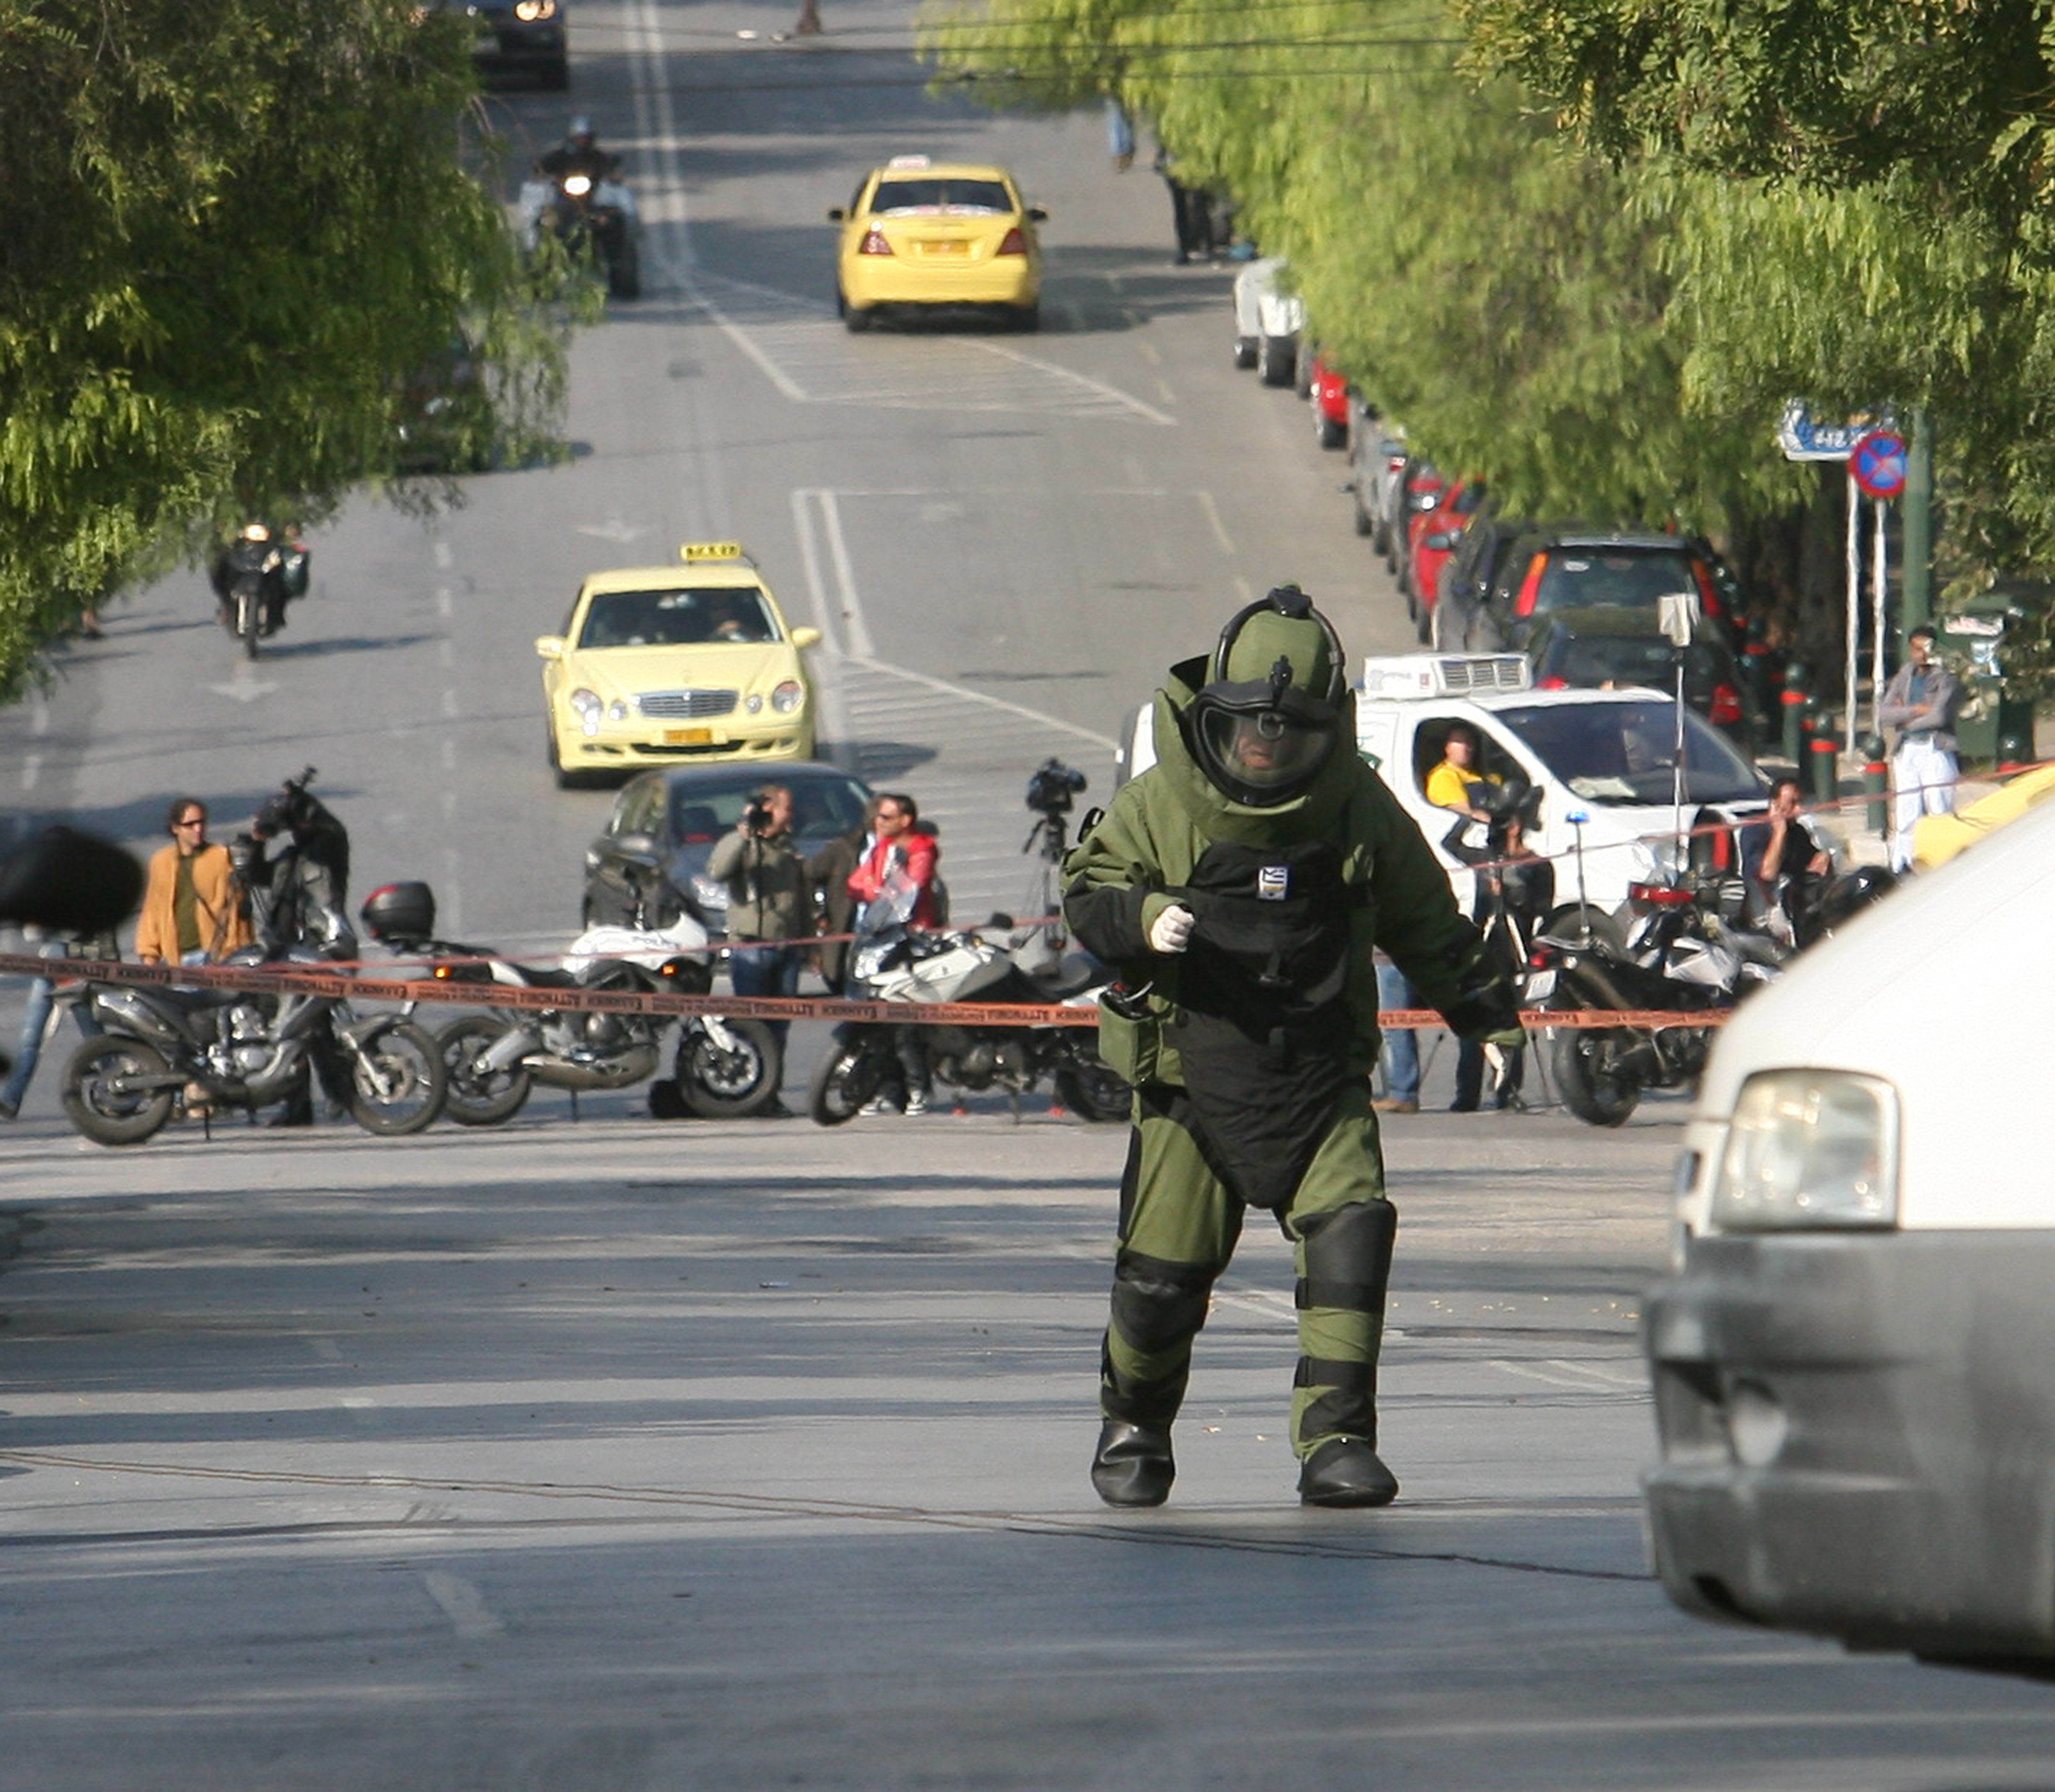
1064,586,1521,1506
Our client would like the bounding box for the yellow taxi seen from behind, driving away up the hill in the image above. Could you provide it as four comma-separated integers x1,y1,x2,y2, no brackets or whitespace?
828,156,1048,329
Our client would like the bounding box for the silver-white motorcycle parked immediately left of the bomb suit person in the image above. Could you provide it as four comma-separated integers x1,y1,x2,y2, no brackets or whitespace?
807,869,1131,1126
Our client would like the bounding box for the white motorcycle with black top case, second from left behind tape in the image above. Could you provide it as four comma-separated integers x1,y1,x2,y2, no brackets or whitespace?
362,881,779,1126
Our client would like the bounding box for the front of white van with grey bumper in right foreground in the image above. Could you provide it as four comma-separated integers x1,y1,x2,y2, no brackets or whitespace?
1644,789,2055,1675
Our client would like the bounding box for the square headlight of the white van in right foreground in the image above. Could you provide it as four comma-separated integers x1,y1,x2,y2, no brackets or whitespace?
1707,1071,1899,1231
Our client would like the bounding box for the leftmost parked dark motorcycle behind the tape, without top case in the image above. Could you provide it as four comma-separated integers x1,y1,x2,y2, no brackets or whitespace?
63,945,444,1145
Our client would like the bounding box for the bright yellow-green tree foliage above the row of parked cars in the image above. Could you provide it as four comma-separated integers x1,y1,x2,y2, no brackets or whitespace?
925,0,1798,526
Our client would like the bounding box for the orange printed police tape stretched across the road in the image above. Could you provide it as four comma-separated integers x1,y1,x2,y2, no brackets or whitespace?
0,954,1726,1030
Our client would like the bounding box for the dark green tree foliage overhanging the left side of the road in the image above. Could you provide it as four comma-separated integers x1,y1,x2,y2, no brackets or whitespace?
0,0,563,690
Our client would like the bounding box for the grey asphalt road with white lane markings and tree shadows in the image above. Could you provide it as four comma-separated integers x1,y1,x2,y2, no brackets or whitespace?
0,0,2055,1792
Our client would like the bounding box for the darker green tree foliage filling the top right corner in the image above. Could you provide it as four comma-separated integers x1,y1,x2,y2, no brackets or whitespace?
1457,0,2055,690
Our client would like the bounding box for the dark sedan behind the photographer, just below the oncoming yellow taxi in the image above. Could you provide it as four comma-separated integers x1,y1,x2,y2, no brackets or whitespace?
582,760,871,937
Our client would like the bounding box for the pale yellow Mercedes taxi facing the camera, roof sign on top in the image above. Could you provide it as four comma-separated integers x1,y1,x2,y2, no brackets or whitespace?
534,541,820,789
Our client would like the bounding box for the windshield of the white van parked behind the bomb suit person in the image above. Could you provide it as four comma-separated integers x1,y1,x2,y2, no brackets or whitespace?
1492,697,1763,803
